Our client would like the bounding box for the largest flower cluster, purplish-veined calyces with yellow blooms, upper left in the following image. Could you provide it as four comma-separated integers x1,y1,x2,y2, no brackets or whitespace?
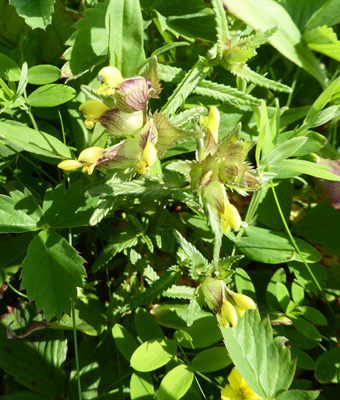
58,63,199,174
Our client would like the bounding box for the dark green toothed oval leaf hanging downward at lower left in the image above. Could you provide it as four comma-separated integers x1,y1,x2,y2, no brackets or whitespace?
21,231,85,320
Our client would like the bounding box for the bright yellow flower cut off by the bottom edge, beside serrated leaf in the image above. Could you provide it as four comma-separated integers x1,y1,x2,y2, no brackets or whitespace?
221,368,262,400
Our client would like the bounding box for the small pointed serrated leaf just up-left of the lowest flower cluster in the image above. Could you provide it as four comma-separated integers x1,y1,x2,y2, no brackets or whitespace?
174,231,209,279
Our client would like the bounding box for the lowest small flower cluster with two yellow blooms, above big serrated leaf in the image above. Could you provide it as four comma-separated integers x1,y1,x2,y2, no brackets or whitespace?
201,277,256,328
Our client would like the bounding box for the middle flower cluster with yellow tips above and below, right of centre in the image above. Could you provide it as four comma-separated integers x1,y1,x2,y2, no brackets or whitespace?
190,107,259,232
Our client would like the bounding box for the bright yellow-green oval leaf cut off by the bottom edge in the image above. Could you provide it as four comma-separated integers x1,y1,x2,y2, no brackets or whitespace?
157,364,194,400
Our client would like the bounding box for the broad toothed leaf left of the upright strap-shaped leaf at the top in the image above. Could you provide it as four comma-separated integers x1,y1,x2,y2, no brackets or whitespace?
62,2,109,78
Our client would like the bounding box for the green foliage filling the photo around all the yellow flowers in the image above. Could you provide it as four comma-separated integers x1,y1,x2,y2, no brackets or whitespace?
0,0,340,400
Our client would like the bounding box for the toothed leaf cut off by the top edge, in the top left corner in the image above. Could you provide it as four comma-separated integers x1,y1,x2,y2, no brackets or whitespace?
9,0,55,29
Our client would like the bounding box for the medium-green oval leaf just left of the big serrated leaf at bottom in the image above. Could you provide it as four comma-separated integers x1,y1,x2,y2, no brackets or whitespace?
191,346,232,373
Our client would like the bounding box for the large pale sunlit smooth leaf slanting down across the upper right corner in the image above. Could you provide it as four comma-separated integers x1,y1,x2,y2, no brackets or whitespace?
223,0,327,86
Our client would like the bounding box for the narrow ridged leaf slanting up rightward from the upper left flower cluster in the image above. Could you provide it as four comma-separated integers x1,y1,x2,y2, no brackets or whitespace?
162,57,210,114
